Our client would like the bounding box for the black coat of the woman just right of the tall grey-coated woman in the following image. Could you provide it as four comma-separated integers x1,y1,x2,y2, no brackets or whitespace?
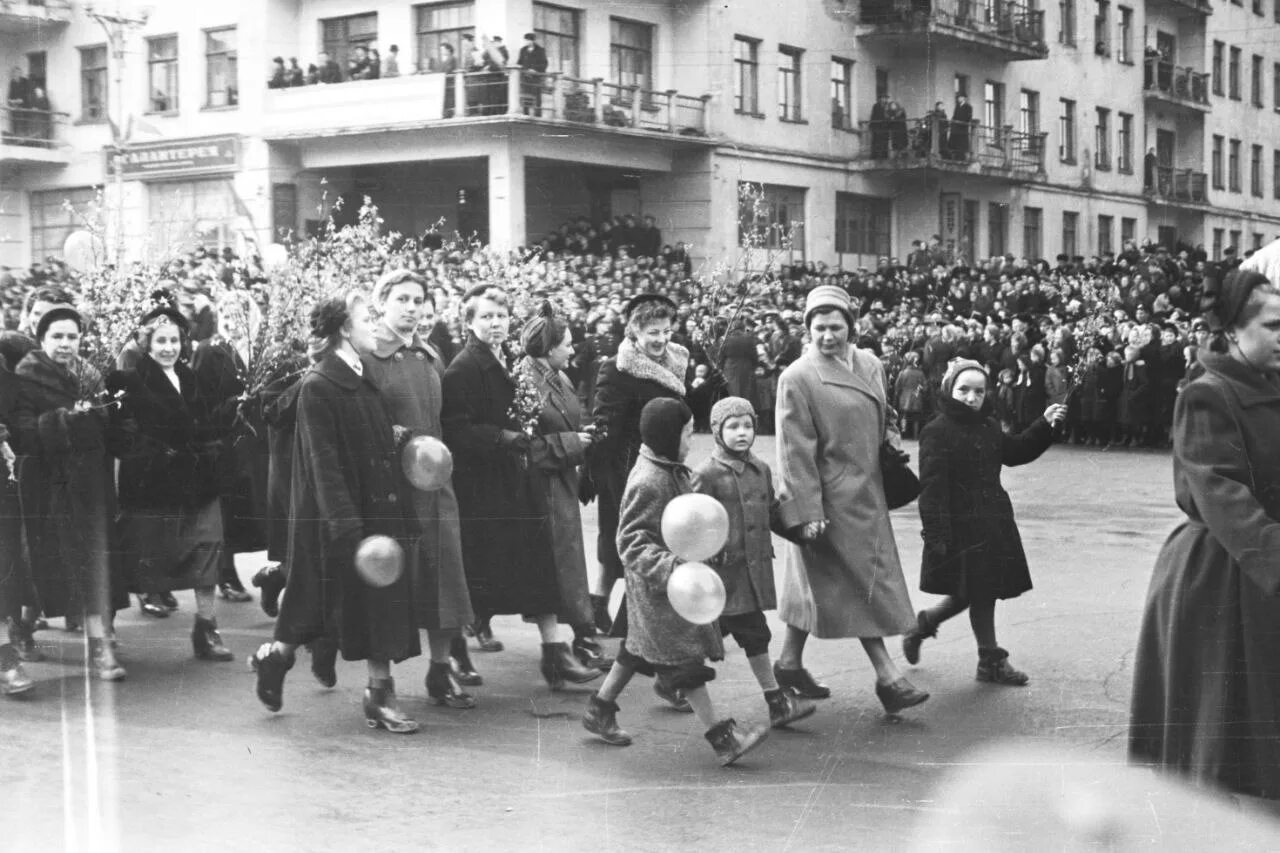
440,337,561,616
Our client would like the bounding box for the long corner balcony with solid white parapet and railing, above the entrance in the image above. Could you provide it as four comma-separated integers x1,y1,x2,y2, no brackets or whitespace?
264,69,710,142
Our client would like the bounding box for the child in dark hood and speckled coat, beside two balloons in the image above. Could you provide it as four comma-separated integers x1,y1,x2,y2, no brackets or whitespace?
582,397,769,765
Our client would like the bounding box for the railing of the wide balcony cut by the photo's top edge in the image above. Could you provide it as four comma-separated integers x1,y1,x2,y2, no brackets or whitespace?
859,0,1048,55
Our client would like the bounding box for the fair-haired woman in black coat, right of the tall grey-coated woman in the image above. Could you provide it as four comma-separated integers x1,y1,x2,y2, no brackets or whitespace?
440,284,600,689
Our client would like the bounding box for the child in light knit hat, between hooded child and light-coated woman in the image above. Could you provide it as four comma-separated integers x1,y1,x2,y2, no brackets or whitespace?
694,397,815,729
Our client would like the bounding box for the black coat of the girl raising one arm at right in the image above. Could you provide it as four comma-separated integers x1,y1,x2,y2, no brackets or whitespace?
916,400,1053,601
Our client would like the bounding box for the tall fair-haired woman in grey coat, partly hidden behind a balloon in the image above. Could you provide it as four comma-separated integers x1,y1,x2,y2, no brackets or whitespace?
365,269,481,708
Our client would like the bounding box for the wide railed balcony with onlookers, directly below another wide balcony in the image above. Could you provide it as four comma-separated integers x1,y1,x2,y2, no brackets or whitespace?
855,115,1048,182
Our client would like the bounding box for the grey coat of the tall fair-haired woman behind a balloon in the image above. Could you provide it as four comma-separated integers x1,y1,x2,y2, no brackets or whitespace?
365,325,475,630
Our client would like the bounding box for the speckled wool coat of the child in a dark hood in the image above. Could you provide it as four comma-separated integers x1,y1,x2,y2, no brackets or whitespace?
618,446,724,666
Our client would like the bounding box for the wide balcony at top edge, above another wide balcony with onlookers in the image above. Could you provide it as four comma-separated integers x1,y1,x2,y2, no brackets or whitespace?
858,0,1048,61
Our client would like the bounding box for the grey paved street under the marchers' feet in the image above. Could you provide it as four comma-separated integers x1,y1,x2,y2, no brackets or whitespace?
0,437,1198,852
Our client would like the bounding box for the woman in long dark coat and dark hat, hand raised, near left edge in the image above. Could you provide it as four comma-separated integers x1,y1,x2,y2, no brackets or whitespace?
14,307,128,681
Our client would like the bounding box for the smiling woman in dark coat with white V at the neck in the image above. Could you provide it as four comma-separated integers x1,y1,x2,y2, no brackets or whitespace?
109,307,234,661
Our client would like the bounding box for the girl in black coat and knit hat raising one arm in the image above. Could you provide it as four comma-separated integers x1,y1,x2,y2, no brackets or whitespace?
902,359,1066,686
